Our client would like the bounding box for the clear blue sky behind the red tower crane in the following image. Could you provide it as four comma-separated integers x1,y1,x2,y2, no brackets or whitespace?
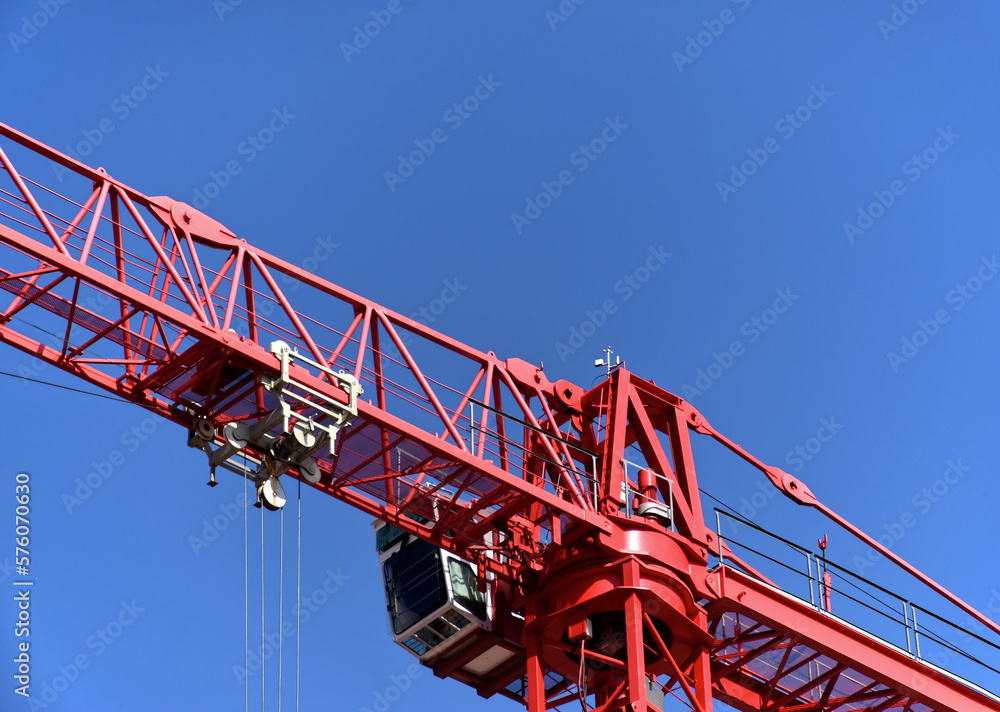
0,0,1000,712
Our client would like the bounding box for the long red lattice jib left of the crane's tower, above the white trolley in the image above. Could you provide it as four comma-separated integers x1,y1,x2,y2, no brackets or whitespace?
0,122,608,573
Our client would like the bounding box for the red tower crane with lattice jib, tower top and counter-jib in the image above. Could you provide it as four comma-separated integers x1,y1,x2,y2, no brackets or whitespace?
0,125,1000,712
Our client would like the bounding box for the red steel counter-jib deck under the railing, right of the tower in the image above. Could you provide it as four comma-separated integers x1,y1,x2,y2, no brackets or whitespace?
708,569,1000,712
